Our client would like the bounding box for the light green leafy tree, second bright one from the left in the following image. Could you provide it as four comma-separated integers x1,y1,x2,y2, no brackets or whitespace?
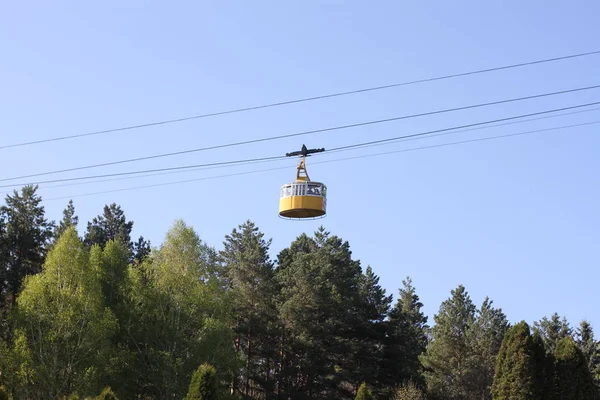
120,221,235,398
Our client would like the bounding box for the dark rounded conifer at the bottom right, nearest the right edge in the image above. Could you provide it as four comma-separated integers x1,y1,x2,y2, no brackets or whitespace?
554,336,598,400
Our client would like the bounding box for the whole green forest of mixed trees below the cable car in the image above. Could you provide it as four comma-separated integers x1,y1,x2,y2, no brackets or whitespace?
0,186,600,400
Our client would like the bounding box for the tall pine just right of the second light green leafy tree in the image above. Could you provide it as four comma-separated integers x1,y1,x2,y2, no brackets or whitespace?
220,221,279,396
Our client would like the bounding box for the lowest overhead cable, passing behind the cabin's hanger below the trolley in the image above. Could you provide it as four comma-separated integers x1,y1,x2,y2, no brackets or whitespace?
45,121,600,201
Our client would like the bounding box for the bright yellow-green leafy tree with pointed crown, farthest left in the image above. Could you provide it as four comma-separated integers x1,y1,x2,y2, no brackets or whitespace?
6,227,117,399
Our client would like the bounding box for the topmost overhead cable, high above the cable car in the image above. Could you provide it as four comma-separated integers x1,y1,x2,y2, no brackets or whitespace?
0,50,600,150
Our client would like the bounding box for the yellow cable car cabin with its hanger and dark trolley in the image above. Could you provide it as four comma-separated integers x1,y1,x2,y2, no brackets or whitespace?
279,146,327,219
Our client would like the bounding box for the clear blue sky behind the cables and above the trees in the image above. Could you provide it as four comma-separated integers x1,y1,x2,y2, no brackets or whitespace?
0,0,600,334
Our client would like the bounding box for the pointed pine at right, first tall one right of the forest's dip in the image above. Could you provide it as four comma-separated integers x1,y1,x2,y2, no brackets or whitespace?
421,285,476,400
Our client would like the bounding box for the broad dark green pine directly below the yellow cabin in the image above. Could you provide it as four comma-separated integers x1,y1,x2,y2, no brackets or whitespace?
276,228,369,399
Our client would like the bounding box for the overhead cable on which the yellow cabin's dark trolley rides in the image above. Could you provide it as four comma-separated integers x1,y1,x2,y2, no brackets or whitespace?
0,101,600,188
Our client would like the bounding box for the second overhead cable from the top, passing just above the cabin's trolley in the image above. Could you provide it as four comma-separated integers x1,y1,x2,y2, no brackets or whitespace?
0,85,600,183
